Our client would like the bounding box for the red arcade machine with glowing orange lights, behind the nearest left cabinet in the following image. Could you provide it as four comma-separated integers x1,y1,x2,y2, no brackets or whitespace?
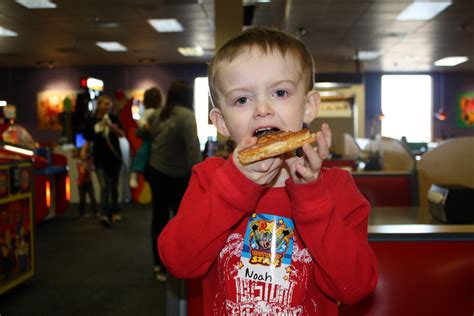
0,105,69,223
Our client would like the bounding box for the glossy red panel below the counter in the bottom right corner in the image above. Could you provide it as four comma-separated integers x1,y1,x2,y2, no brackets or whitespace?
339,240,474,316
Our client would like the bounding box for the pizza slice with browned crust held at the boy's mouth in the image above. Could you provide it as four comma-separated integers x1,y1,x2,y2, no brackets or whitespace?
238,128,316,165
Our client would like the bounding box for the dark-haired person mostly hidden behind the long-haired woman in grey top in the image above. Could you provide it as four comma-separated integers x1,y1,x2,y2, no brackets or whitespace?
130,88,162,188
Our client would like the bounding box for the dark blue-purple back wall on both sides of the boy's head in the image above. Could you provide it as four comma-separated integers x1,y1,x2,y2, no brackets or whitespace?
0,64,474,142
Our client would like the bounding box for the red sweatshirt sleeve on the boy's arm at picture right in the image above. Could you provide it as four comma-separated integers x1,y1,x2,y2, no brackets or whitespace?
287,170,378,304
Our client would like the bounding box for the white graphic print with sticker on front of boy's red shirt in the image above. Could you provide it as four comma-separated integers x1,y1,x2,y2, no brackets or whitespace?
217,214,316,316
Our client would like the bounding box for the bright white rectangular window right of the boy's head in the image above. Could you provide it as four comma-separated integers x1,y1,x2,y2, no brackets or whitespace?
382,75,432,142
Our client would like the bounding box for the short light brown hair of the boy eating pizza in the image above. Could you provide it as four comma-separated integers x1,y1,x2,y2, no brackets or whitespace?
208,27,315,107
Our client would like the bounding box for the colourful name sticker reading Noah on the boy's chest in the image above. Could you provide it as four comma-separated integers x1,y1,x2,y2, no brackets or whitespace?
238,214,294,289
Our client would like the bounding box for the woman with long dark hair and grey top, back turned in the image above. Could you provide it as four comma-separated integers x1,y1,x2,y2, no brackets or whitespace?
139,80,202,281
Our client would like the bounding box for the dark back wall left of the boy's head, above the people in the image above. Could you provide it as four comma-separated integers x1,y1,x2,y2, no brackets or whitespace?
0,64,207,142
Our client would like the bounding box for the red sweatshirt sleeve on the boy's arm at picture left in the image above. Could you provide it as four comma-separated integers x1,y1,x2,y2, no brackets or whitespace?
158,158,265,278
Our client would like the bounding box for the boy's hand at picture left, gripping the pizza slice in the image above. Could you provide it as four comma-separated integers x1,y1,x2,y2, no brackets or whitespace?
232,137,283,185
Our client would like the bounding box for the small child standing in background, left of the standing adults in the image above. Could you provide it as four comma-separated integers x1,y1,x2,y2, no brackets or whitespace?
73,149,99,218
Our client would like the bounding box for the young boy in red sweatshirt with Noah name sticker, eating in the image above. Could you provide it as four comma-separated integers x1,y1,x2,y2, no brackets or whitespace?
159,28,378,315
